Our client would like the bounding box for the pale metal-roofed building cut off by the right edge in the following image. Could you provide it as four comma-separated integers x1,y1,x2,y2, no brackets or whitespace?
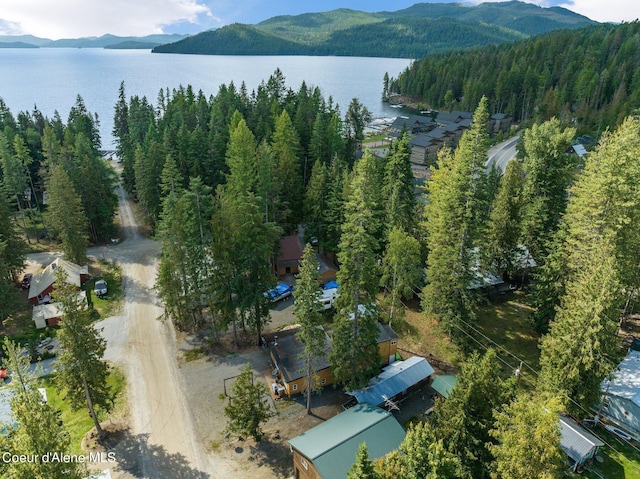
600,349,640,435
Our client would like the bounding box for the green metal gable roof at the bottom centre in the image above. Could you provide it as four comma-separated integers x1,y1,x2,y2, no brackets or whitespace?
289,404,405,479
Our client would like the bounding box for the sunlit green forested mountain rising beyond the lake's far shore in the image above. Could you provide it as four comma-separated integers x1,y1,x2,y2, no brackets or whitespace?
153,2,595,58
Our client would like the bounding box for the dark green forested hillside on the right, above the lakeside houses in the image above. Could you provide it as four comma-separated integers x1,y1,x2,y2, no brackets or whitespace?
390,21,640,131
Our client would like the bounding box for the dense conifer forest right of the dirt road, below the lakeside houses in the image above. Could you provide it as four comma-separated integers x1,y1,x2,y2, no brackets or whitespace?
114,63,640,479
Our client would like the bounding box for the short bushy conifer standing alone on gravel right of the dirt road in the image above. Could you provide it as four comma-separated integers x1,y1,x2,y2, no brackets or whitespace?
224,364,272,441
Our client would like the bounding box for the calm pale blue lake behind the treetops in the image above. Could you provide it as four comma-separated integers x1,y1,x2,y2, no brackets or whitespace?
0,48,411,149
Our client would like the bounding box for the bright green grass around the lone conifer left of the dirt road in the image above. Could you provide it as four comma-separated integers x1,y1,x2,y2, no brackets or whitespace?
39,368,126,454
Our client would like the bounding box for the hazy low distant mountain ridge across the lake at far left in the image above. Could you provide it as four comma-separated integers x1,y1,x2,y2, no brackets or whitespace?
0,34,188,49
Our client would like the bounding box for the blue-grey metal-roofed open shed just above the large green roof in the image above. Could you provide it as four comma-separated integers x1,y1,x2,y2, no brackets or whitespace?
347,356,434,406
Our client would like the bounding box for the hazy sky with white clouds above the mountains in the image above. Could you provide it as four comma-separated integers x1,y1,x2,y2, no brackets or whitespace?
0,0,640,39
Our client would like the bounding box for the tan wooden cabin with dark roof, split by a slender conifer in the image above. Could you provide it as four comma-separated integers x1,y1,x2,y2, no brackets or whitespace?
269,326,334,398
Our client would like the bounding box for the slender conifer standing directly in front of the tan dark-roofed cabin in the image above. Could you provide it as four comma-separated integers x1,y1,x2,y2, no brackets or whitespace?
293,244,326,414
